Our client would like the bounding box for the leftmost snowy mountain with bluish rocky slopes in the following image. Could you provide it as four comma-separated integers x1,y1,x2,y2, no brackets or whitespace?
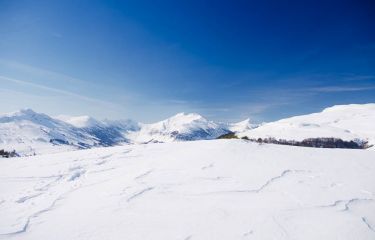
0,109,99,155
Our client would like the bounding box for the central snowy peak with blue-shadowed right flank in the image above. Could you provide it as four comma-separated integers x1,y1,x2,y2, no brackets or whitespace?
127,113,229,143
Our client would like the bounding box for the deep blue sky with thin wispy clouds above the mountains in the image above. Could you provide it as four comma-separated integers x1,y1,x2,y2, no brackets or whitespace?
0,0,375,122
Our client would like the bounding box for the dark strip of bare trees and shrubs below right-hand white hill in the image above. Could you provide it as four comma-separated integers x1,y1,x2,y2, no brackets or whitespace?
218,133,372,149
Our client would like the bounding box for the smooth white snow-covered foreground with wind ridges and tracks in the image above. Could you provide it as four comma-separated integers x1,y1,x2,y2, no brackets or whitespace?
0,140,375,240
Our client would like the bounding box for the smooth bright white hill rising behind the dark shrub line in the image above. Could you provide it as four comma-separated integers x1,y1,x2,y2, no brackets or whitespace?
238,103,375,147
